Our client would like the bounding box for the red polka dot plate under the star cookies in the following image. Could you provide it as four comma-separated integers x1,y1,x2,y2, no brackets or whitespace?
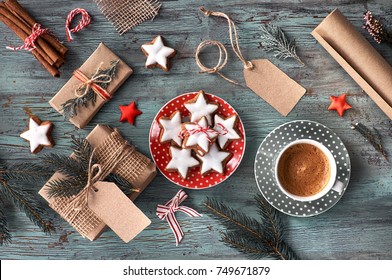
150,92,246,189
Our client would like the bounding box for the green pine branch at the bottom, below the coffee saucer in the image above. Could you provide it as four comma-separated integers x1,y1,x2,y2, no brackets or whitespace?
204,195,297,260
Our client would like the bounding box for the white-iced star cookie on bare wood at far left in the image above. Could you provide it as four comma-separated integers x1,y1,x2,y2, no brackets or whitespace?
20,116,54,154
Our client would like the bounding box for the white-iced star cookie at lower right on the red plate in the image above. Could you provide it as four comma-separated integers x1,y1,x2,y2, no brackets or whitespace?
196,143,231,176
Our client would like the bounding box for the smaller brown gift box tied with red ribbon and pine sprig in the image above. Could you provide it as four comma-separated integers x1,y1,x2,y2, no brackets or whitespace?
49,43,133,128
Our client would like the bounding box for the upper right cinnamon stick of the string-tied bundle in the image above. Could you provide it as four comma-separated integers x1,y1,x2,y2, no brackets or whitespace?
4,0,68,57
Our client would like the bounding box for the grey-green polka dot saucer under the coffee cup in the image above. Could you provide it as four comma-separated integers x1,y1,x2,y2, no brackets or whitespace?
254,120,351,217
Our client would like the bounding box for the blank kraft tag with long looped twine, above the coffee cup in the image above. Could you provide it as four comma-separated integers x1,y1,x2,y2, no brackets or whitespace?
196,7,306,116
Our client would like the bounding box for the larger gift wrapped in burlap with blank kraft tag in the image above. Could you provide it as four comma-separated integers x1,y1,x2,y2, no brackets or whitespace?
39,125,156,242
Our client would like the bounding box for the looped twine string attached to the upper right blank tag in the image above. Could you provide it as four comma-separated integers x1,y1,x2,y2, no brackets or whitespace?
195,7,253,85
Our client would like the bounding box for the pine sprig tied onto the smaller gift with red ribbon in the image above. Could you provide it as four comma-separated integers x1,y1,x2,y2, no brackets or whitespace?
60,60,119,120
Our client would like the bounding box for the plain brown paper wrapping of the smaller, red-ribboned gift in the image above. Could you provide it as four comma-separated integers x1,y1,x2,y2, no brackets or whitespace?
49,43,133,128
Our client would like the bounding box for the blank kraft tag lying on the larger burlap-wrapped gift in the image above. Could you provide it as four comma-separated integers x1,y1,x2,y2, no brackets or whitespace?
88,182,151,243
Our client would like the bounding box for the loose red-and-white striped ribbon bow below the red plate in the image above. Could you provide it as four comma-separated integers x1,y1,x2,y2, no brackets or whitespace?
157,190,202,246
